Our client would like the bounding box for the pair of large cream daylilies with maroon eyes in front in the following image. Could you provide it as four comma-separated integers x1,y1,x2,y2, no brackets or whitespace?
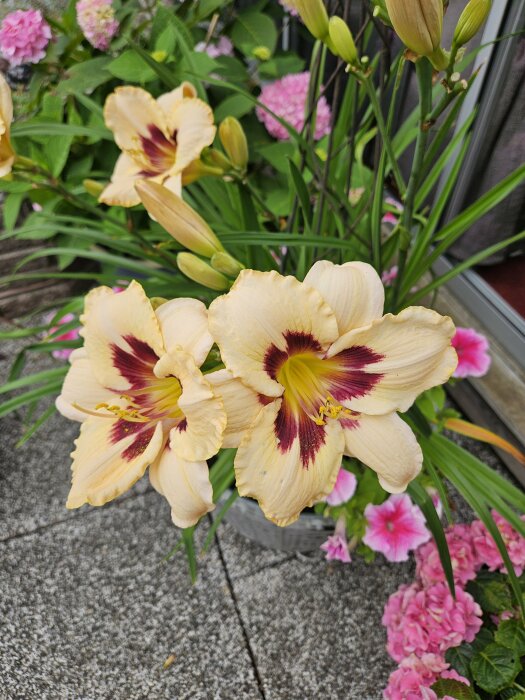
57,261,457,527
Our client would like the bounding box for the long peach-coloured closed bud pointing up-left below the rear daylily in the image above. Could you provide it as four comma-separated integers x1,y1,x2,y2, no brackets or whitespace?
135,180,224,258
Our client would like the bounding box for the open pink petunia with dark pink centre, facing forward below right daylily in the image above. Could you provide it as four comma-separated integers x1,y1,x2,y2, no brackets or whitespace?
363,494,430,561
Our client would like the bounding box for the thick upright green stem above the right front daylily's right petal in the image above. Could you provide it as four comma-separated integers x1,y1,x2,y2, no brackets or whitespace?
392,58,432,311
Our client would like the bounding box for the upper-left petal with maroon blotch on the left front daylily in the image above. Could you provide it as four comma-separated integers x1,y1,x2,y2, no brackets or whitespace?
80,281,164,391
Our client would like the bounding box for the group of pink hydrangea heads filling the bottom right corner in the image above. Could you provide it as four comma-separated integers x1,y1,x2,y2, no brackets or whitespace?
383,511,525,700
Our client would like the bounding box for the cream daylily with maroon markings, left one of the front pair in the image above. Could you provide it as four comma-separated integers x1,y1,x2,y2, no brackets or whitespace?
57,282,226,527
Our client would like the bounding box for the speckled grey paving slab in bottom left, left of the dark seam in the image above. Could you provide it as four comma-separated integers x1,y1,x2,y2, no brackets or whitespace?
0,493,260,700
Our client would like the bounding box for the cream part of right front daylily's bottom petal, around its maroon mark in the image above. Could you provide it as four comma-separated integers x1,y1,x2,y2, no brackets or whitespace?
235,399,344,527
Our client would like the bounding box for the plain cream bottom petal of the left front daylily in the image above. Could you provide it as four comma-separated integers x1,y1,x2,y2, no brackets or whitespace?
149,447,215,527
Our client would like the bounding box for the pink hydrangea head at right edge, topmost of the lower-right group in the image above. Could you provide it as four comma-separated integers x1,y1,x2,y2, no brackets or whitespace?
471,510,525,576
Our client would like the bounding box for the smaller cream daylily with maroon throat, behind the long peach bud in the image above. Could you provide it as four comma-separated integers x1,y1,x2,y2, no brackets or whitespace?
99,82,215,207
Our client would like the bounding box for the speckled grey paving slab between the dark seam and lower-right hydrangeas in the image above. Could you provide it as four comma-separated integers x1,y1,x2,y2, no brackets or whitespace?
215,525,413,700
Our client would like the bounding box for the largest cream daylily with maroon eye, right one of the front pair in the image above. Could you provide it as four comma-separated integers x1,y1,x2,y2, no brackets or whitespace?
209,261,457,525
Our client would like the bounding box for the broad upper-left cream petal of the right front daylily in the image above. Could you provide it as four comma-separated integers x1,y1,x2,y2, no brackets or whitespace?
209,270,338,396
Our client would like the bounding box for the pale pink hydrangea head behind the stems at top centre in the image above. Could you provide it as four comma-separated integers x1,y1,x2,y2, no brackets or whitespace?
255,71,331,141
